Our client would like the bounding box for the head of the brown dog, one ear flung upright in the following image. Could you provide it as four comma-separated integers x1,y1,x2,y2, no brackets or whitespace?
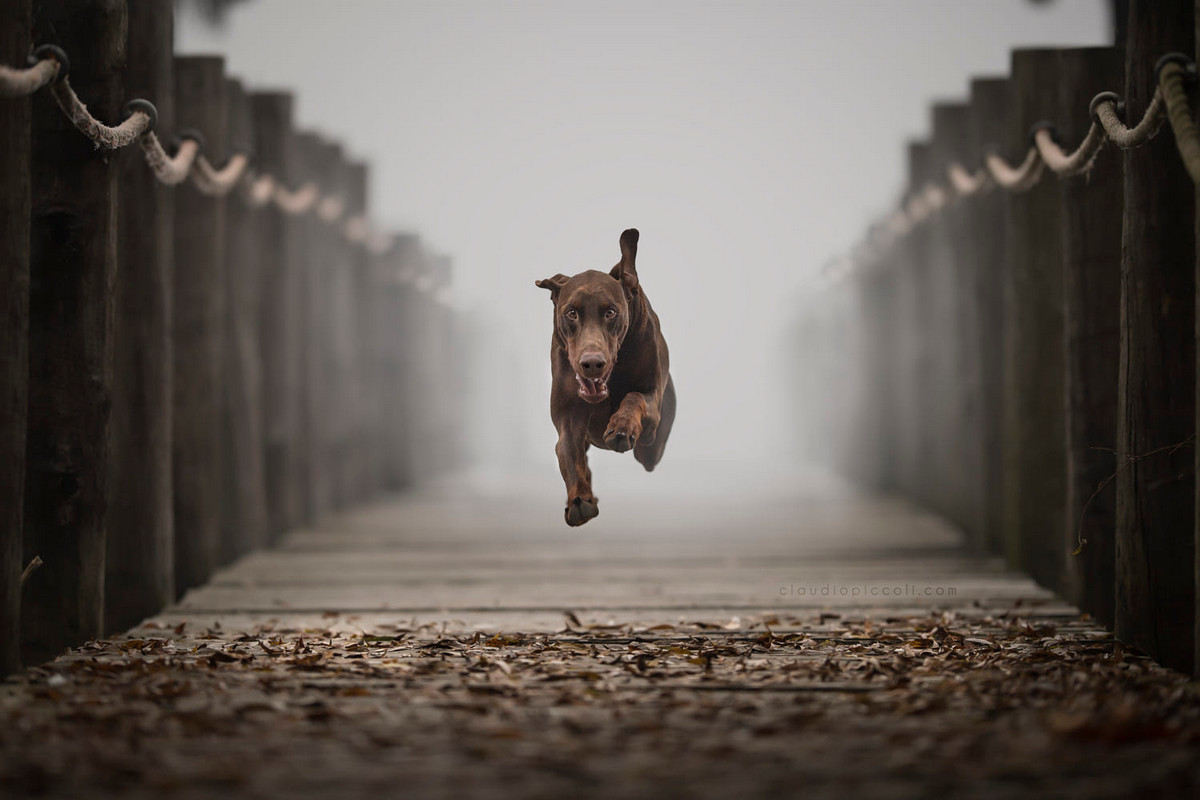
536,228,638,403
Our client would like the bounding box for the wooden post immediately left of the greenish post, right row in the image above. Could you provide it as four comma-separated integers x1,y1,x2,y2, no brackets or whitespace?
962,78,1014,554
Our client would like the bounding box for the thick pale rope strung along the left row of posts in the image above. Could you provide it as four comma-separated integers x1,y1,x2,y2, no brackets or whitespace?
0,44,416,284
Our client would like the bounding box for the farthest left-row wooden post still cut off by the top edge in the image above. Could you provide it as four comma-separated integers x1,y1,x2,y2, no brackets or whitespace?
104,0,175,631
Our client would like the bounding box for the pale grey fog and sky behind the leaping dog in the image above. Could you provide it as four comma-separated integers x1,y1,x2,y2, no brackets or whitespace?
176,0,1111,484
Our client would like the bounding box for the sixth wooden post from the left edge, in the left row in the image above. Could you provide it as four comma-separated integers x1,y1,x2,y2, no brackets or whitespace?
251,92,300,541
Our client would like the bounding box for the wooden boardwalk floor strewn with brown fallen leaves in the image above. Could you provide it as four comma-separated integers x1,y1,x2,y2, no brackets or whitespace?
0,464,1200,800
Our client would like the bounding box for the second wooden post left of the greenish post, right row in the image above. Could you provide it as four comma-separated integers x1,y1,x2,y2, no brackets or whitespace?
926,103,979,543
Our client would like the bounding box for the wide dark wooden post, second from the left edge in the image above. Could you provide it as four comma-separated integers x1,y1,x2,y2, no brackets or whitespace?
20,0,126,663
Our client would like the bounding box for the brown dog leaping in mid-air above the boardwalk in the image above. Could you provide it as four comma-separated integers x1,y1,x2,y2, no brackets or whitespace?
538,228,676,525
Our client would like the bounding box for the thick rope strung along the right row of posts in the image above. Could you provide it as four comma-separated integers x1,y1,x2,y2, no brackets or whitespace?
821,53,1200,283
